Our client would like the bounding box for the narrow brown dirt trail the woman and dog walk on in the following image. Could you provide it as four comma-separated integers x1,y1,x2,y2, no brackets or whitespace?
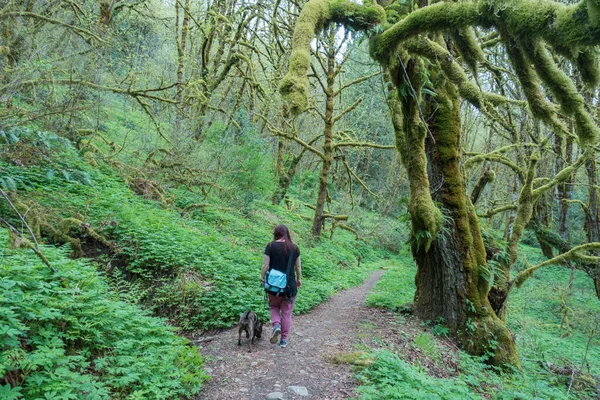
197,271,383,400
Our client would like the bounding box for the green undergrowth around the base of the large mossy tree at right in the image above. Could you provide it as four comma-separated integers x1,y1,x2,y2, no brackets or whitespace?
357,241,600,400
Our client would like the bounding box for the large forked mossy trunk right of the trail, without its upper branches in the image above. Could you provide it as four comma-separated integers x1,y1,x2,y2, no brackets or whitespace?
390,61,519,365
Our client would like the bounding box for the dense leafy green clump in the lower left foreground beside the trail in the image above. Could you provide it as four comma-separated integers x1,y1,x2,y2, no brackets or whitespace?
0,229,207,399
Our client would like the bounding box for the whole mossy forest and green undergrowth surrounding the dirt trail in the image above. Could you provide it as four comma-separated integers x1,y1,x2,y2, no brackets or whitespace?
0,0,600,398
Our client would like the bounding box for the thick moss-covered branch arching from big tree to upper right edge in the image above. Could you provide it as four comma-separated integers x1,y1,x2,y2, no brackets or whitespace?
371,0,600,63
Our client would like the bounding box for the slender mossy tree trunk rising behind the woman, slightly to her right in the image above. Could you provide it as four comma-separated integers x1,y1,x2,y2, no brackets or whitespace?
312,29,336,237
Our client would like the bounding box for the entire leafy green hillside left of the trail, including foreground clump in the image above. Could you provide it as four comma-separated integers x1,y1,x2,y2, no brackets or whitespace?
0,122,398,398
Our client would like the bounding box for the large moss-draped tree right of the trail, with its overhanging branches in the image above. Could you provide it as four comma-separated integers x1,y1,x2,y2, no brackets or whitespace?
280,0,600,365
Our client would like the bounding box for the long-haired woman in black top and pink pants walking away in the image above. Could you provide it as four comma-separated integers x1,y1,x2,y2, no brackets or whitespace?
261,225,302,348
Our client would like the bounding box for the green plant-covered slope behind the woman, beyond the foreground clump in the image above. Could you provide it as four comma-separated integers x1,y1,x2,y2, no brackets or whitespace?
0,126,390,331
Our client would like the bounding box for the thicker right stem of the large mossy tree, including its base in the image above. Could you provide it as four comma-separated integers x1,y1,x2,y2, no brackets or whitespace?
420,84,518,365
